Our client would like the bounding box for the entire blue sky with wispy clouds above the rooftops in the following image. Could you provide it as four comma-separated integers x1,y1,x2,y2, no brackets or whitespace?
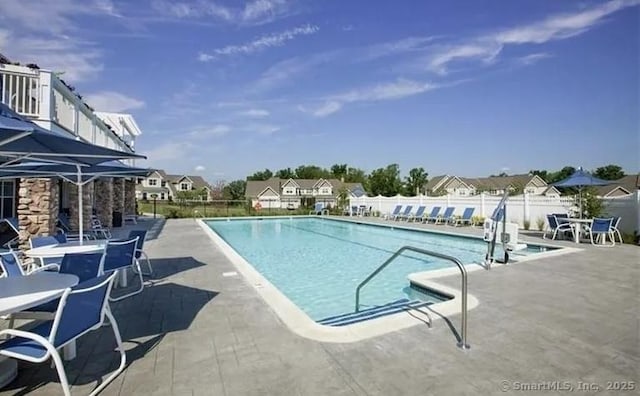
0,0,640,181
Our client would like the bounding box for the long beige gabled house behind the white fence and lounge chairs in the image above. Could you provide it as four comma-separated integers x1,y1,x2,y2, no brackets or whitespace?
425,174,560,197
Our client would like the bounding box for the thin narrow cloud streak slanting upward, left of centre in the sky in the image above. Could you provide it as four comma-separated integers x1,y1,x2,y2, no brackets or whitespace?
198,25,319,62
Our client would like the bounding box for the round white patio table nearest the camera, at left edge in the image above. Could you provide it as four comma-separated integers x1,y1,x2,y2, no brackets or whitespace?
0,272,78,388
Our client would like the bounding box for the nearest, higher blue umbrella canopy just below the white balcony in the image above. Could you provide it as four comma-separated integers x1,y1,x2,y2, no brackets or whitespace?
0,103,146,166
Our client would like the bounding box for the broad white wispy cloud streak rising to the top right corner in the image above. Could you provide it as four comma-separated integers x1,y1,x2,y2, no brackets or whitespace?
427,0,640,75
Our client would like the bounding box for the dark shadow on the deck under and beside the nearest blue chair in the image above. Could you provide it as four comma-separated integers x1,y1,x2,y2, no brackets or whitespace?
4,283,219,395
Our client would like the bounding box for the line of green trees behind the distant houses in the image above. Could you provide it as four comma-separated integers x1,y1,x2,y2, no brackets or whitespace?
222,164,625,200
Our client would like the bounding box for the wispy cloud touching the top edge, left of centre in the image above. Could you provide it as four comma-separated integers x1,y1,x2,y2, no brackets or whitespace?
151,0,292,24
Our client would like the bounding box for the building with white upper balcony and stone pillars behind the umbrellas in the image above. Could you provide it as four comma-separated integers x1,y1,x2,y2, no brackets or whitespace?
0,54,142,249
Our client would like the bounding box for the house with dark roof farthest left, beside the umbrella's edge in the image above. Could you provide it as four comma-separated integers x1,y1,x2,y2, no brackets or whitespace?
136,169,212,201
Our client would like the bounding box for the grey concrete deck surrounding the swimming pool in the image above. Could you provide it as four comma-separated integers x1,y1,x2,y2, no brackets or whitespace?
0,219,640,396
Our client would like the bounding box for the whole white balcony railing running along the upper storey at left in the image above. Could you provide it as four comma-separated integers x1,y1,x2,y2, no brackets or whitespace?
0,64,133,155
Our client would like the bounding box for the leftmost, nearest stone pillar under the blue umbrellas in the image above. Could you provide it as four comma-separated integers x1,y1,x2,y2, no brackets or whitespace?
17,179,60,249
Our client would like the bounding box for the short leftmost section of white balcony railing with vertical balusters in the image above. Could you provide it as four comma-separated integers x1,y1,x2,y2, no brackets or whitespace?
0,65,40,116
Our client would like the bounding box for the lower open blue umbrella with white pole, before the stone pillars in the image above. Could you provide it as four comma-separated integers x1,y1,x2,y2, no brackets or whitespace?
0,161,153,241
